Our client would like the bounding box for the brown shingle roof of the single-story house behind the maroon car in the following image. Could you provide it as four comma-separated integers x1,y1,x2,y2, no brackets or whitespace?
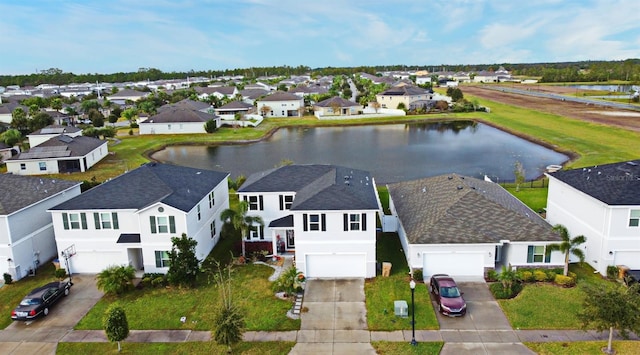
389,174,560,244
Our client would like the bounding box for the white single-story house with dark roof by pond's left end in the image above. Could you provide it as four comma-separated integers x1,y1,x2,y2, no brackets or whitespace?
5,134,109,175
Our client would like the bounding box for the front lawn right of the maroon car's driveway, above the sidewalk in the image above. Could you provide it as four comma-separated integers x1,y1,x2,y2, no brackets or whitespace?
498,264,613,329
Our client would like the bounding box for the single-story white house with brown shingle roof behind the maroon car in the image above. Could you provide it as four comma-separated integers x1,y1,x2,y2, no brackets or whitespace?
385,174,564,279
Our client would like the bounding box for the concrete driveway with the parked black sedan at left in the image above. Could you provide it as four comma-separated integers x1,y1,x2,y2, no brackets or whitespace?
0,274,103,354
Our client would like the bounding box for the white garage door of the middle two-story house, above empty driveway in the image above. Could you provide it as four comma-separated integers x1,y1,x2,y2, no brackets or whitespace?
305,254,367,278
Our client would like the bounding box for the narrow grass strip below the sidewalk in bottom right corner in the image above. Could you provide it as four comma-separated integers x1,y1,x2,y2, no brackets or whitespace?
524,341,640,355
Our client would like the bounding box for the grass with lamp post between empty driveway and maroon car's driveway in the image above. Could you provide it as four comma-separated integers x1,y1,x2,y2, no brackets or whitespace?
365,233,438,330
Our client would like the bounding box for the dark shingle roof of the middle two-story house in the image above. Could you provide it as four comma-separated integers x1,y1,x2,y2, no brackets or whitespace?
238,164,380,211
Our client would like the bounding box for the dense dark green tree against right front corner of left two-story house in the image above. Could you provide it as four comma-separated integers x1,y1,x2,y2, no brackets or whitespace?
167,233,200,287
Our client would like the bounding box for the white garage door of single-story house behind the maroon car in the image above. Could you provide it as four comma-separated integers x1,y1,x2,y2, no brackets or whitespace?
423,253,484,277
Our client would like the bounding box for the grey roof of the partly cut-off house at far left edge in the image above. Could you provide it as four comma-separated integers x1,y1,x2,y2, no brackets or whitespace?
0,174,80,215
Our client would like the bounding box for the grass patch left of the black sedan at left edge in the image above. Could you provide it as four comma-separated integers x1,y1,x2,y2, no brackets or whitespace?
0,260,56,329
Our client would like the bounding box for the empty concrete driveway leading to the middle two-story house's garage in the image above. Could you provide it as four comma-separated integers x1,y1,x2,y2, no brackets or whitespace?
290,279,376,354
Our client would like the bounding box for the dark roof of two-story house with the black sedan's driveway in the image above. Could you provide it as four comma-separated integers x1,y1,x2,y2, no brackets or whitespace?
52,163,229,212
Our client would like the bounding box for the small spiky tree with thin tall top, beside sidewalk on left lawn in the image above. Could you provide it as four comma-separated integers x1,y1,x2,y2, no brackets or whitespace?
213,264,245,353
